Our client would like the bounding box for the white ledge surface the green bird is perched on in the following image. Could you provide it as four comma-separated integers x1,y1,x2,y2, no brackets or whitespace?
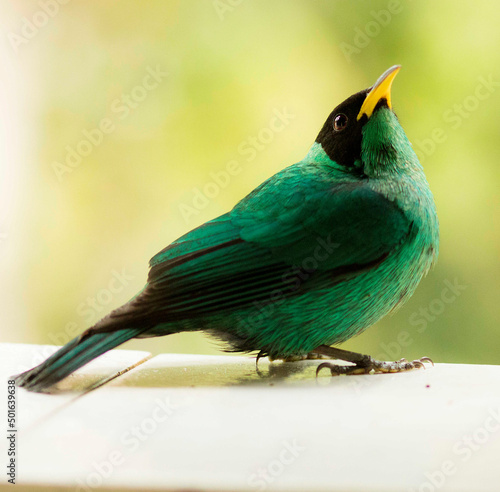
0,344,500,492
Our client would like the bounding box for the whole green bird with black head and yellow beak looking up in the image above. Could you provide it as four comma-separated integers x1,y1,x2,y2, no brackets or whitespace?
15,66,439,391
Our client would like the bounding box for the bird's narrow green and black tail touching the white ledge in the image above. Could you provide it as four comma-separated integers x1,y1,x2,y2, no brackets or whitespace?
13,328,144,392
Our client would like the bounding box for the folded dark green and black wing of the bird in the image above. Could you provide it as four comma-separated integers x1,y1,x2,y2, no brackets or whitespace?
103,168,411,324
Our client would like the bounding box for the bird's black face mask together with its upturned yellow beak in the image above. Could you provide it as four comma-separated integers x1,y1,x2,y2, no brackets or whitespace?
316,65,399,169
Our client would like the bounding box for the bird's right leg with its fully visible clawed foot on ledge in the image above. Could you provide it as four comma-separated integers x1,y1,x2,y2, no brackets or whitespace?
312,345,434,376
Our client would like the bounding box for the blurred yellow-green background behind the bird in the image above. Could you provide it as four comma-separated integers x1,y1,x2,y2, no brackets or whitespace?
0,0,500,363
